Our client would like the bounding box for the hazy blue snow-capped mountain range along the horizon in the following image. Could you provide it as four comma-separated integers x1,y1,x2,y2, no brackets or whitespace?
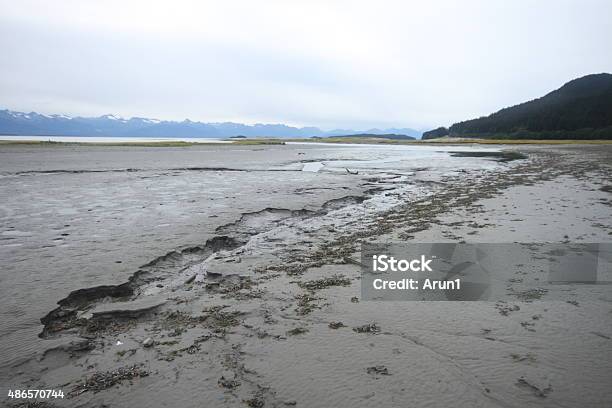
0,110,421,138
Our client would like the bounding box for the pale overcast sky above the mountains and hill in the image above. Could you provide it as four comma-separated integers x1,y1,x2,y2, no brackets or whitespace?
0,0,612,130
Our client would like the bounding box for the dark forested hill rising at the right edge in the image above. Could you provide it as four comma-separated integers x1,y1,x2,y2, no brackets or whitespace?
423,73,612,139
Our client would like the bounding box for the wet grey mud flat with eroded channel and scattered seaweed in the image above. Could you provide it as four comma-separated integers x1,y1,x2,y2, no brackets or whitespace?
0,144,612,407
